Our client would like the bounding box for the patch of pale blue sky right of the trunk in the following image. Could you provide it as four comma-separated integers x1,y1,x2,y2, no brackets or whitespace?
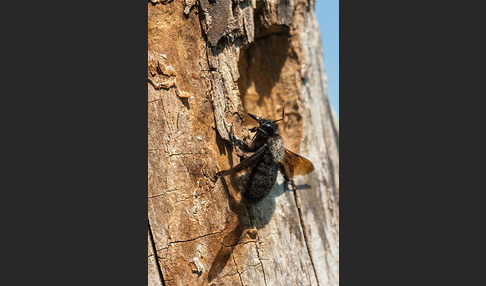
315,0,339,118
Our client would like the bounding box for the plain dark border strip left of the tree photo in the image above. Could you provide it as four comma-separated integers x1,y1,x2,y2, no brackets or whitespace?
2,1,147,285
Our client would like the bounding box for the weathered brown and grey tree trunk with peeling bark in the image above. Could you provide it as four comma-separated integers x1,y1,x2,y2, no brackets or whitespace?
148,0,339,285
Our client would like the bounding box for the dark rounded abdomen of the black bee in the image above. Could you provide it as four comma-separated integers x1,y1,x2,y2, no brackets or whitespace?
243,162,277,201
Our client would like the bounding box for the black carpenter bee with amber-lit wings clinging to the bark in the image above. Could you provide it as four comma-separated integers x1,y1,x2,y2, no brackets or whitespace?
218,103,314,202
